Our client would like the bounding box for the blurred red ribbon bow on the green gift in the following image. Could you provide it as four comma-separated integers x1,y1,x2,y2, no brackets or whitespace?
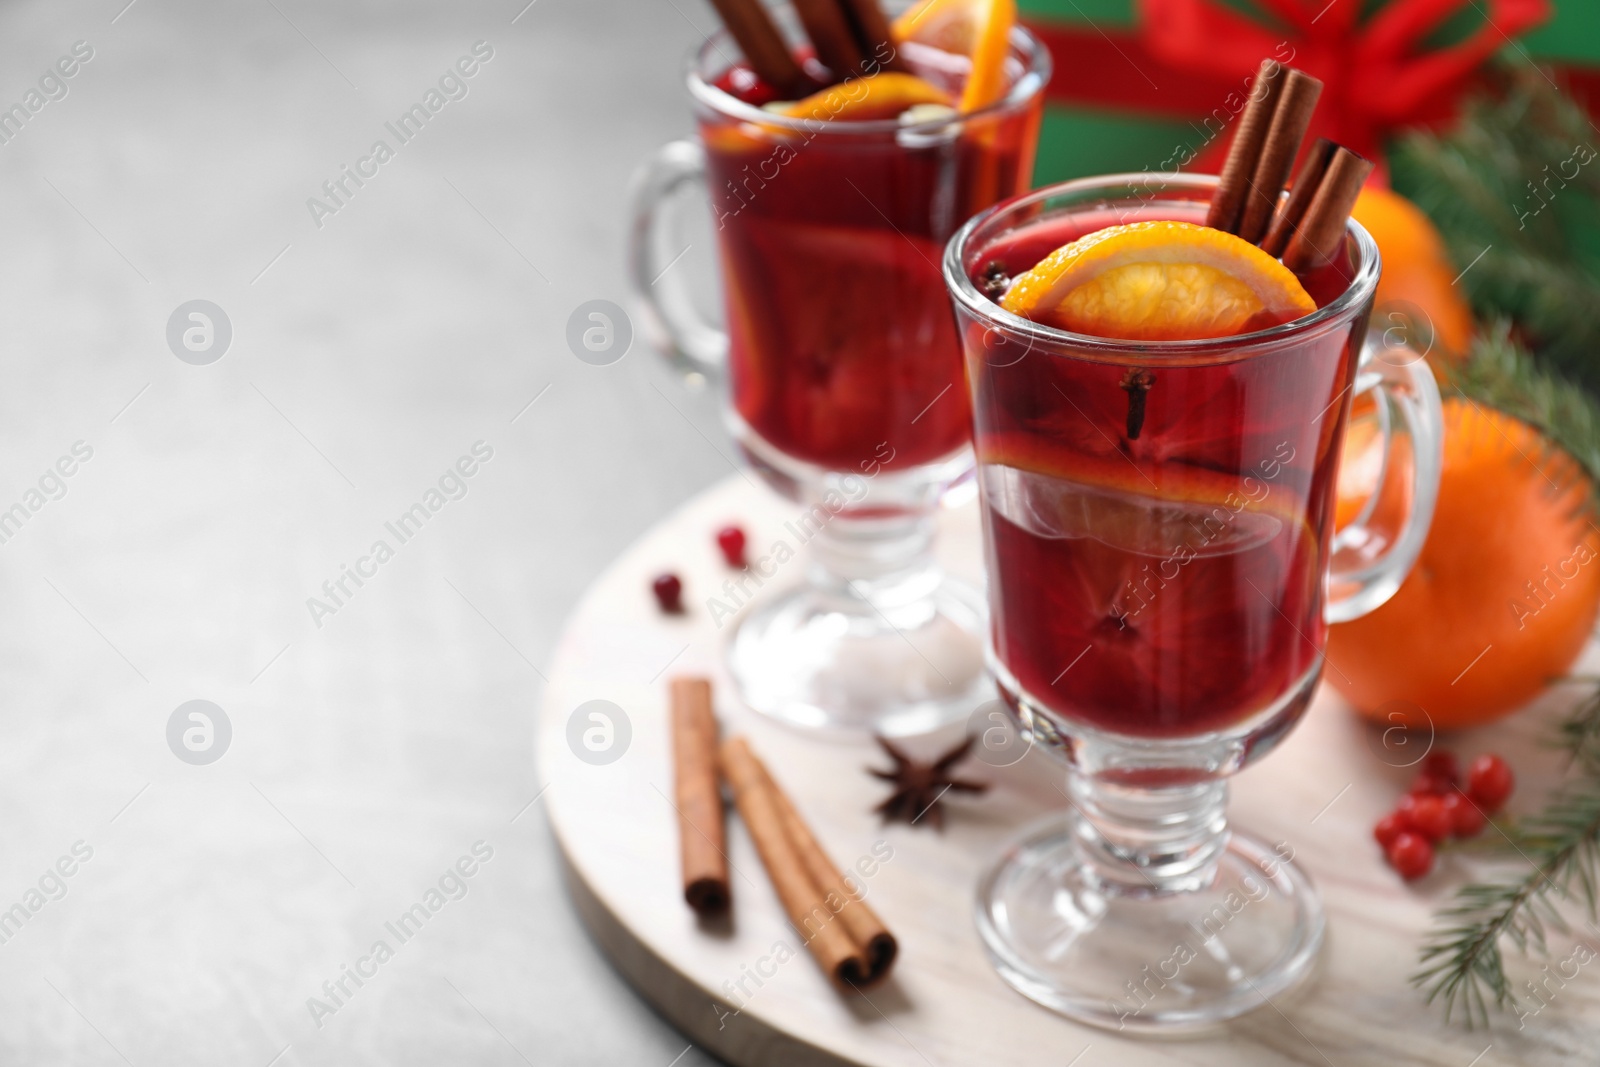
1139,0,1550,158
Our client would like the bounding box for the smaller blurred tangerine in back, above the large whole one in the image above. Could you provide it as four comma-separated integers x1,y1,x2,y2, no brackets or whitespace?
1350,186,1472,357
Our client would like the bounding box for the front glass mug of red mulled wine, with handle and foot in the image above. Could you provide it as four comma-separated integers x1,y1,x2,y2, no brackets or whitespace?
944,174,1440,1030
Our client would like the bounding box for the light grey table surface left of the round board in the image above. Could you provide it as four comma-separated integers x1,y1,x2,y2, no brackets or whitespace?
0,0,728,1067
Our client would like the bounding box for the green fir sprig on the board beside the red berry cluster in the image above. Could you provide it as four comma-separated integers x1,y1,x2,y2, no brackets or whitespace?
1411,774,1600,1027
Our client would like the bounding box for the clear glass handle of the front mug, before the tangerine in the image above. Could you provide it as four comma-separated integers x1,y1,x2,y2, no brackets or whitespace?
1323,331,1443,622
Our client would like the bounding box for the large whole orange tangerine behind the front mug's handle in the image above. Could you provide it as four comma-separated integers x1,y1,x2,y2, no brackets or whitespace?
1323,398,1600,729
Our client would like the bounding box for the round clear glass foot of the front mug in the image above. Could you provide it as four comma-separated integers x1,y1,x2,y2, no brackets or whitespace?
978,814,1325,1033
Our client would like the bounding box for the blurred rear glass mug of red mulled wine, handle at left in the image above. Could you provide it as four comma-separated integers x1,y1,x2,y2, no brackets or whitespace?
632,8,1050,734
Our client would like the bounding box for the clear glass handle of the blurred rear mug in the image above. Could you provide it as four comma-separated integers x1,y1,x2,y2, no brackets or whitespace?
627,141,728,378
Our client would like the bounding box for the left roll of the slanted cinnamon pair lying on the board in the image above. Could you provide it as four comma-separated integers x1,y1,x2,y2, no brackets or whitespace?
722,737,869,985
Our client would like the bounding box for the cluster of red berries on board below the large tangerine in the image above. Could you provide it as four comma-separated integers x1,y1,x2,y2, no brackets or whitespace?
1373,752,1515,881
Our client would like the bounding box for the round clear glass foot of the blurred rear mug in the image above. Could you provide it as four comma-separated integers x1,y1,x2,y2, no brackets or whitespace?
728,576,994,737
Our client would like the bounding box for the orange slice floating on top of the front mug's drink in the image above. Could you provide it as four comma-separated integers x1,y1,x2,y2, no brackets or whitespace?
1000,221,1317,341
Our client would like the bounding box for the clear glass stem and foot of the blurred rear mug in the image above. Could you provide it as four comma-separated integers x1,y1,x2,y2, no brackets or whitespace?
728,460,994,736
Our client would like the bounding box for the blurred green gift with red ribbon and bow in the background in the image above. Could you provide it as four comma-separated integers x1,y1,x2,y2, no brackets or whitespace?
1019,0,1600,184
